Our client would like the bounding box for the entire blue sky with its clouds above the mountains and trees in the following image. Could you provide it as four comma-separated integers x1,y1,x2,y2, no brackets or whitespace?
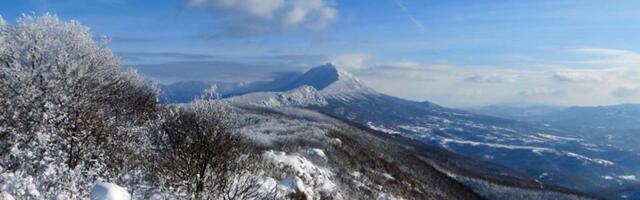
0,0,640,107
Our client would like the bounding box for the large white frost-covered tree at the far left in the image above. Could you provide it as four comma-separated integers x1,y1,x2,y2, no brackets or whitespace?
0,14,156,196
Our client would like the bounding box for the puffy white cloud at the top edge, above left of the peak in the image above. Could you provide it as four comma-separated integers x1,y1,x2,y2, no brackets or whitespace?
186,0,338,36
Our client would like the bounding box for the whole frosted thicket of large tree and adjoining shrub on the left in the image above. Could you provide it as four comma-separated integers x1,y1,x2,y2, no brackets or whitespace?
0,14,284,200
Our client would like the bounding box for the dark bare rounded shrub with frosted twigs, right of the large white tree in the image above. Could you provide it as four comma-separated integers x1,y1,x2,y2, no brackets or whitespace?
149,102,269,200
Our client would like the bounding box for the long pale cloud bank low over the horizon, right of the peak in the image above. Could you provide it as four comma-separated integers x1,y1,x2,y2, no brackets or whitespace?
355,49,640,106
